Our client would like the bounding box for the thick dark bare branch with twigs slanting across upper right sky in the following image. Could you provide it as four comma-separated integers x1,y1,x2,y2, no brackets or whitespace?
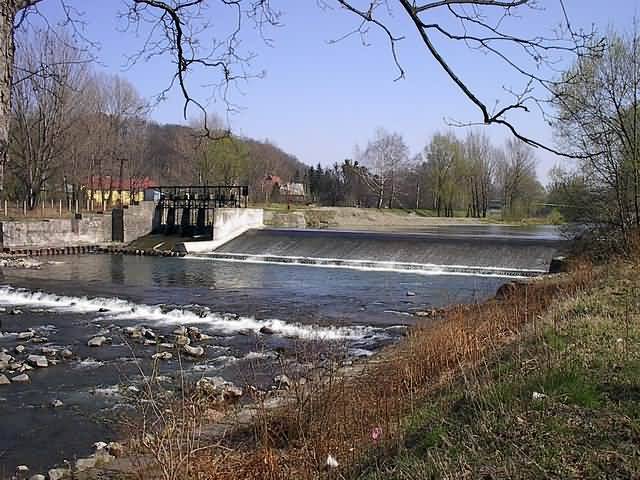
337,0,602,158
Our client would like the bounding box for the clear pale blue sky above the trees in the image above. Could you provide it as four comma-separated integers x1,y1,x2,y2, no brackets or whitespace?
33,0,640,183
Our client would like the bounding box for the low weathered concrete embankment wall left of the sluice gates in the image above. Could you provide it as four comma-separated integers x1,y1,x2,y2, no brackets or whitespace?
0,202,155,249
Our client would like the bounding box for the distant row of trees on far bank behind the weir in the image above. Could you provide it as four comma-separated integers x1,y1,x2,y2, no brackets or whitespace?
306,128,545,218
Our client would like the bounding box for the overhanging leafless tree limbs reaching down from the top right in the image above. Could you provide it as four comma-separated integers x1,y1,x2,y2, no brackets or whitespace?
328,0,603,158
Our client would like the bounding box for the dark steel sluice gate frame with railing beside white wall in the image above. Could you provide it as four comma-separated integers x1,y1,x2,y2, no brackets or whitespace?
153,185,249,237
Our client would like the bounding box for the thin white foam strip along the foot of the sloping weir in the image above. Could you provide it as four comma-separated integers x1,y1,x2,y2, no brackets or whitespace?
183,252,548,278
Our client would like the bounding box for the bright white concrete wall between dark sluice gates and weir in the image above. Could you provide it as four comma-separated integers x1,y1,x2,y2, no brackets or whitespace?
176,208,264,253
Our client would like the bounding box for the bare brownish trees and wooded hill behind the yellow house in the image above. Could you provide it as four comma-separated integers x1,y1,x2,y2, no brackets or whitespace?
5,29,304,209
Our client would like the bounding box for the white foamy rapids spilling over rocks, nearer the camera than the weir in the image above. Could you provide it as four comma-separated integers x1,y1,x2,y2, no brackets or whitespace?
0,286,390,341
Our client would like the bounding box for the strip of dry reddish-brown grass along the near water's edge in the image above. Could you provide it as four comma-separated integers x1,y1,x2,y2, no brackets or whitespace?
159,262,594,480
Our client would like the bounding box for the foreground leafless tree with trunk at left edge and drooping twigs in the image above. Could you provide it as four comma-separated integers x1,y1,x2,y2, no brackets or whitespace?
0,0,278,195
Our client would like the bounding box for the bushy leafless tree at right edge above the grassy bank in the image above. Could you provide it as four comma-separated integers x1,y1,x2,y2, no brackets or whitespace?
555,23,640,242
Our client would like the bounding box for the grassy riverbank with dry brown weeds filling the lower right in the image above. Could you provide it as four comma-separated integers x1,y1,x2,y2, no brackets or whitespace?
110,246,640,480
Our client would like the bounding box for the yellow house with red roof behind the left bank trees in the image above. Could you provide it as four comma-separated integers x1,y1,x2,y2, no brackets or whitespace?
81,175,156,205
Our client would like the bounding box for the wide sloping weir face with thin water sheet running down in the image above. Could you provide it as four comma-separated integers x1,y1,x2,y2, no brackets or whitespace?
196,229,564,276
